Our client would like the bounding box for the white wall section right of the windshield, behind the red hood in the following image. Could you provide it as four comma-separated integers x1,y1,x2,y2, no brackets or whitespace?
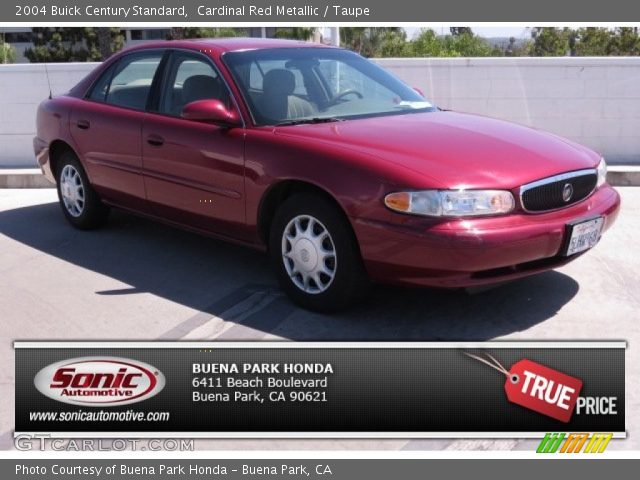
377,57,640,164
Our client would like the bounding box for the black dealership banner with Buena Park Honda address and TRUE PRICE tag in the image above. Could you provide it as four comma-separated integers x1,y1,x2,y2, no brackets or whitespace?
14,342,626,438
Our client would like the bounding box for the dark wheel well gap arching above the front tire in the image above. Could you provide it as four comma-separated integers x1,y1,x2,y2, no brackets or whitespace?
258,180,346,246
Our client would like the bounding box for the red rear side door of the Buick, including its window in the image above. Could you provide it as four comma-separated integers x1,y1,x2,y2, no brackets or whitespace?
70,50,165,210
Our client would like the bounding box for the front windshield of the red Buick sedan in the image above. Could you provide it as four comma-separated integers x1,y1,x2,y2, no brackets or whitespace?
223,48,436,125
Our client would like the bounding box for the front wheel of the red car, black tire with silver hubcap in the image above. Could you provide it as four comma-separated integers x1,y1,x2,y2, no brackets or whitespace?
269,193,369,312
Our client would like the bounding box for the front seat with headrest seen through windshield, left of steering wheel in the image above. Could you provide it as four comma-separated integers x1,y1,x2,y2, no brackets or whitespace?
258,69,317,122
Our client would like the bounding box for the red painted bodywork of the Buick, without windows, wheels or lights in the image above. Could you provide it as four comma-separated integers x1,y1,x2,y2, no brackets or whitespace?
34,39,620,287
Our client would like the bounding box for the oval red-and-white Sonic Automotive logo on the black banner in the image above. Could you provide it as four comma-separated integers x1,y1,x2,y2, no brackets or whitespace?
34,357,165,407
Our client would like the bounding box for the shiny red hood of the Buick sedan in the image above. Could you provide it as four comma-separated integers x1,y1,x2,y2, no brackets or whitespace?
275,111,599,189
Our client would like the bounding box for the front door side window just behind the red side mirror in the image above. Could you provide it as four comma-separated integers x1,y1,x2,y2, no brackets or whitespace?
160,52,230,116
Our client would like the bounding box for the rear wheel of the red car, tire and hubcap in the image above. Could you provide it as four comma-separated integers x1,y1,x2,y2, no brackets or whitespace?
56,151,109,230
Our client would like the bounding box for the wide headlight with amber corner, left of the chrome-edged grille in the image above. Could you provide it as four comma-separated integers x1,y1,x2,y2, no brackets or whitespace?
384,190,515,217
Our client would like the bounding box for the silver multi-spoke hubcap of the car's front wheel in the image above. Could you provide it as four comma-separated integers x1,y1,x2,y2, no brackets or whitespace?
282,215,337,294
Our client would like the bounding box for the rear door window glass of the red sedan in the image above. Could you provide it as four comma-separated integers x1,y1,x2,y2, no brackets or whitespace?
89,52,162,110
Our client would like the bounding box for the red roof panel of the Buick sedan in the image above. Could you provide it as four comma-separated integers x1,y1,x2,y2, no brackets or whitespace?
120,37,332,54
